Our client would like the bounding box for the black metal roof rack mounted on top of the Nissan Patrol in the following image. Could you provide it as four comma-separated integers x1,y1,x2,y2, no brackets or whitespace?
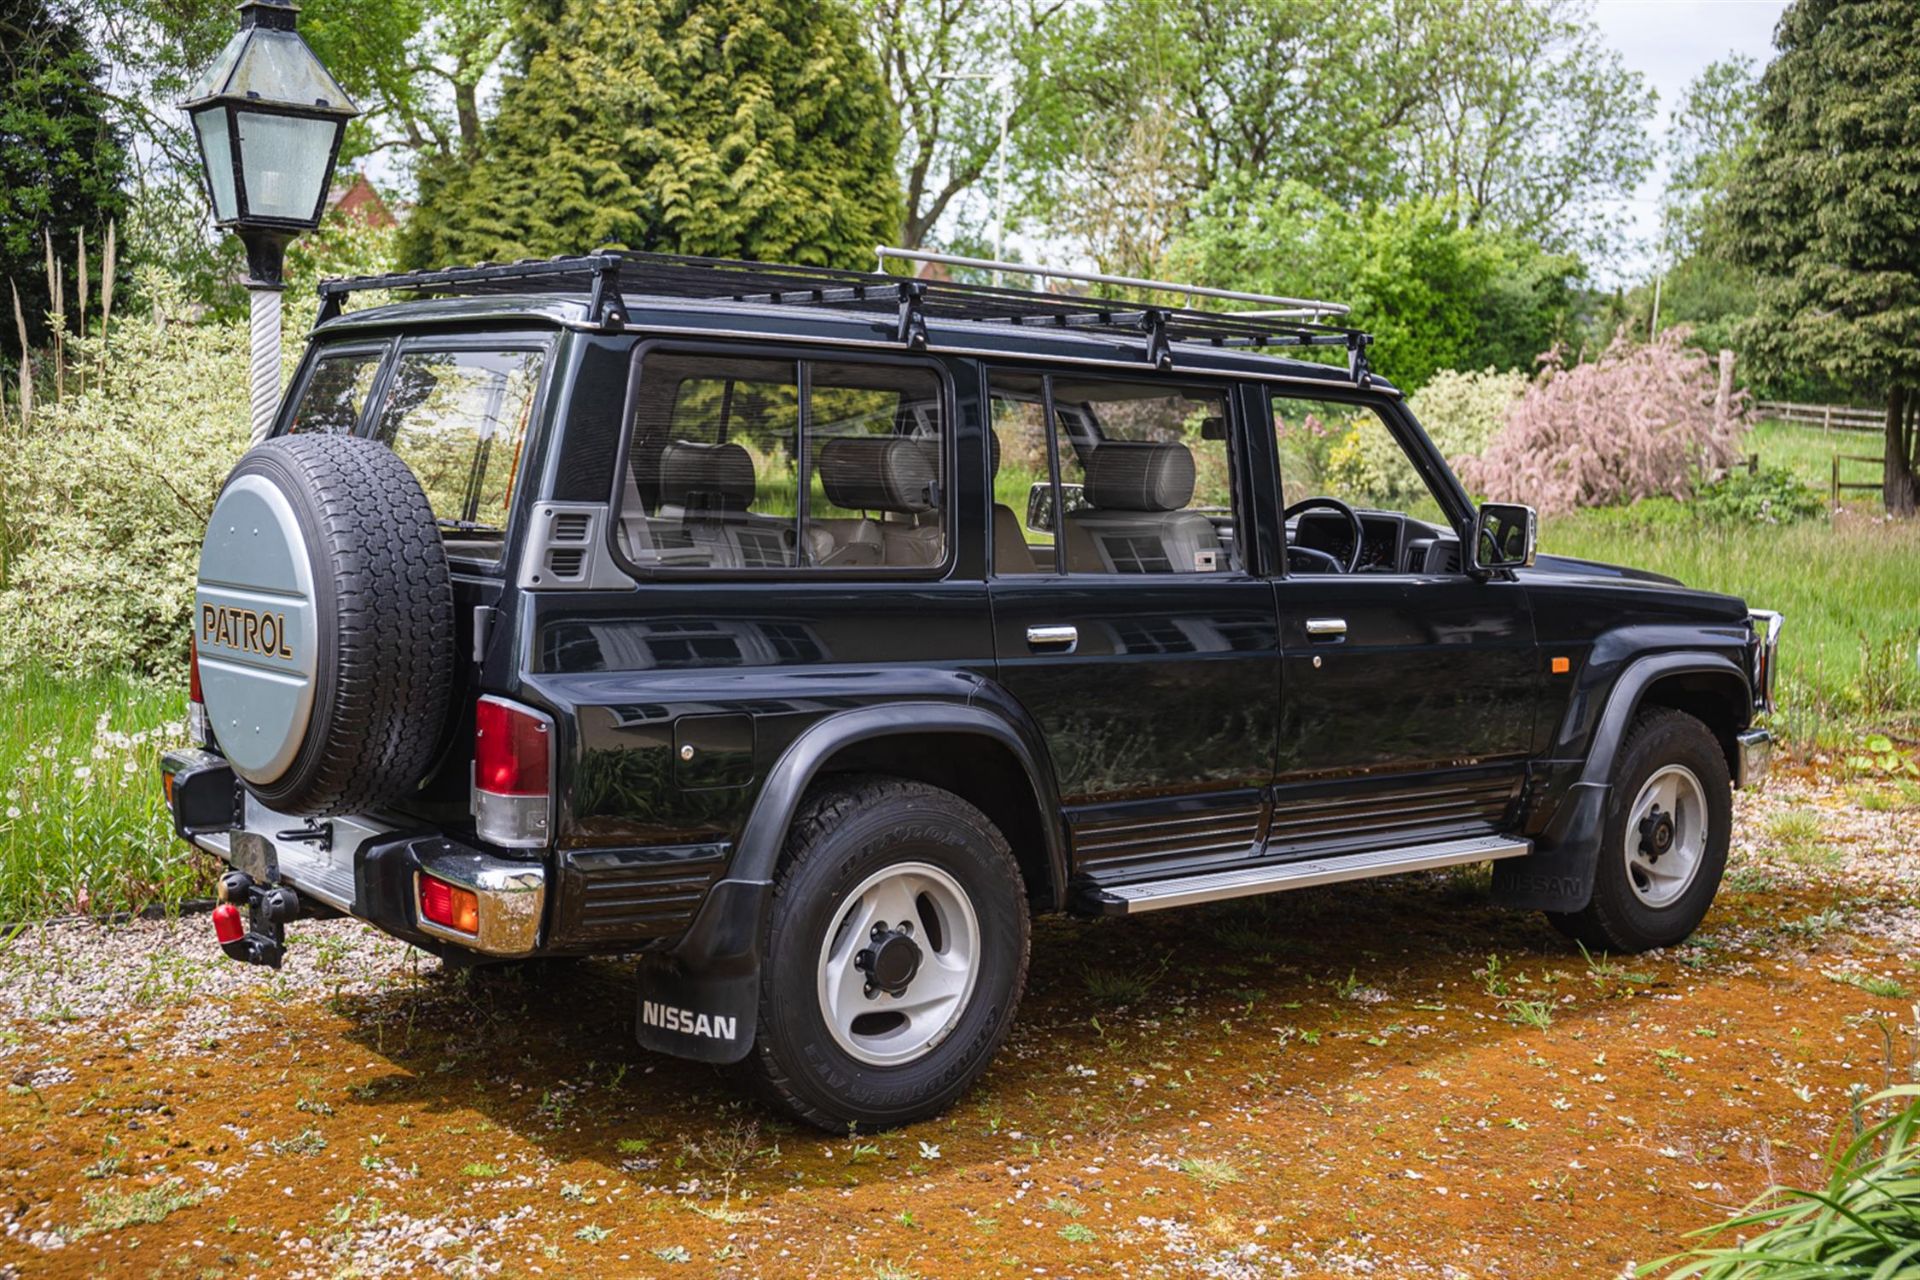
315,248,1373,386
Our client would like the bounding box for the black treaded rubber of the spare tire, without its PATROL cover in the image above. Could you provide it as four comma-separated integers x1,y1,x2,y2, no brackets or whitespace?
215,436,455,818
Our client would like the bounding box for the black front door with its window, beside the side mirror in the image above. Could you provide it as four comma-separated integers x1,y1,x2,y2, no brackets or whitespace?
1267,385,1542,856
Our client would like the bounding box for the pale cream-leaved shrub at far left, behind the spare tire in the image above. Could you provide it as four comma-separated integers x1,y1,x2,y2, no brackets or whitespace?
0,280,264,674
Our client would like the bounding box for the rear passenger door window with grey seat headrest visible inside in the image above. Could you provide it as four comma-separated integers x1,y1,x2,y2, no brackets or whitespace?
993,376,1238,574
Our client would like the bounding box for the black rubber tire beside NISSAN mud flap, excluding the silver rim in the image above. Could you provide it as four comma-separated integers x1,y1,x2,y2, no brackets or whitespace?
741,777,1031,1134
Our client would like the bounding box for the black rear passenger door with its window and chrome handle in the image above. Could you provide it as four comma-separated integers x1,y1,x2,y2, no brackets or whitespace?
989,370,1279,879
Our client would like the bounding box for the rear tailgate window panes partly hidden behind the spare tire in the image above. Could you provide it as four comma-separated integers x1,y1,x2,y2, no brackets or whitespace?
292,347,543,560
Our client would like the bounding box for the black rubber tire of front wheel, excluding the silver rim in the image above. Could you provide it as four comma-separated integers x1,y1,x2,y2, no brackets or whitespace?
1548,706,1734,954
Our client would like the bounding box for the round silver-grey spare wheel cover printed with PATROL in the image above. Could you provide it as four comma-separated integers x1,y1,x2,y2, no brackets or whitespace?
194,472,332,785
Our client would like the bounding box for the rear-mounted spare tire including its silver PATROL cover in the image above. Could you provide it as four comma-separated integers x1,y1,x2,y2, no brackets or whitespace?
194,436,453,818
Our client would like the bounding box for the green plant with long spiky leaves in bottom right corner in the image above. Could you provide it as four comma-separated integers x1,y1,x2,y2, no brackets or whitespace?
1638,1084,1920,1280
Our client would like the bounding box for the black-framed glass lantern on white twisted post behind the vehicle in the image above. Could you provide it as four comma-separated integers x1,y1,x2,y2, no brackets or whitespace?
180,0,359,443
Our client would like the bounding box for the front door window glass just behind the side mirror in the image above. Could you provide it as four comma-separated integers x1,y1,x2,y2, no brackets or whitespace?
1273,395,1448,528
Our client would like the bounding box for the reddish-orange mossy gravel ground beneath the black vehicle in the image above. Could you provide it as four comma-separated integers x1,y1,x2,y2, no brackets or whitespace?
0,767,1920,1278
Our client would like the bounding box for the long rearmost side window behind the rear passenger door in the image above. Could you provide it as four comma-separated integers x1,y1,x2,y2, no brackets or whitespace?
618,351,948,572
